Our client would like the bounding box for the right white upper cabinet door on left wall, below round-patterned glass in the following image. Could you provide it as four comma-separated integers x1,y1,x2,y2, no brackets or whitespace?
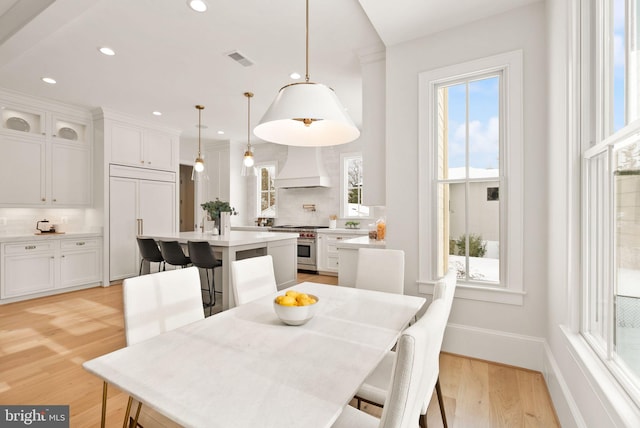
51,143,91,206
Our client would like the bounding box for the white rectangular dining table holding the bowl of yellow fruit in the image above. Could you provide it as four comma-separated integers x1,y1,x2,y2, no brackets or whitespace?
83,282,425,428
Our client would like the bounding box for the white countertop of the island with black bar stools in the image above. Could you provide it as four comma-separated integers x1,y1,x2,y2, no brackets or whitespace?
142,230,298,247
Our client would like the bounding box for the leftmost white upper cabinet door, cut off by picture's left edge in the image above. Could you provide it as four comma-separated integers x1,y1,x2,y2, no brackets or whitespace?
0,135,47,206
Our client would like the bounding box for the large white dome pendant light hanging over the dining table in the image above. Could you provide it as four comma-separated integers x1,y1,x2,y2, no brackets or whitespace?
253,0,360,146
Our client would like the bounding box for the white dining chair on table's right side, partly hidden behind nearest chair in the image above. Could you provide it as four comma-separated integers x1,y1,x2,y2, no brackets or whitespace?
356,271,457,428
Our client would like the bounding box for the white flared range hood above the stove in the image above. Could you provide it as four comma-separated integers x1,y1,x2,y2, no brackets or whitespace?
275,146,331,189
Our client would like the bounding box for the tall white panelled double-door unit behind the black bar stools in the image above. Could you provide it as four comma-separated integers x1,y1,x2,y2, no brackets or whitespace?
109,165,177,281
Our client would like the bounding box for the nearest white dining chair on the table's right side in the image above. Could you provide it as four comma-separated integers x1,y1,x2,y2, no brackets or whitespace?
333,299,447,428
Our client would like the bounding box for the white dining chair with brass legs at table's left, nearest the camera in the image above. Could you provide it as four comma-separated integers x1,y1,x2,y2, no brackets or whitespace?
122,267,204,426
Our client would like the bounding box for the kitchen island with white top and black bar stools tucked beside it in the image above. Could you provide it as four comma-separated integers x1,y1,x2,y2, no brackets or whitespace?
145,230,298,310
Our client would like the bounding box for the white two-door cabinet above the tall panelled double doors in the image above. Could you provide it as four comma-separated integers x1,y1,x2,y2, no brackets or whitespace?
109,122,177,171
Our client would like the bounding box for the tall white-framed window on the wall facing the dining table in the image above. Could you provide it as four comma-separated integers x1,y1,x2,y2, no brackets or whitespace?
419,51,523,304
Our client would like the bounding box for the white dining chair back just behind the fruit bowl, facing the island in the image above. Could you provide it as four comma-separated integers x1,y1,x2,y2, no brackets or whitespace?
231,255,278,306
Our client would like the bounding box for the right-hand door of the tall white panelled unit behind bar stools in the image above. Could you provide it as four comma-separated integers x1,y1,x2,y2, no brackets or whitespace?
138,180,176,235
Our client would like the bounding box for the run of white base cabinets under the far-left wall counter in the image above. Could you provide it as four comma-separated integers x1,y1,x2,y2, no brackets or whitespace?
0,237,102,301
